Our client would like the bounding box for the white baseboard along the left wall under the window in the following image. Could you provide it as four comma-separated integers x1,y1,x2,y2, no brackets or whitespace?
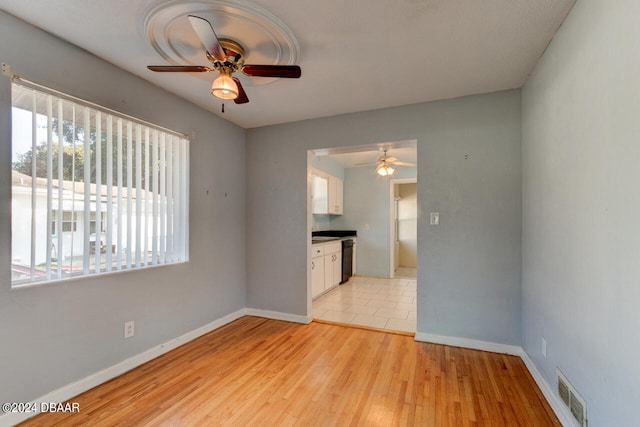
0,309,247,427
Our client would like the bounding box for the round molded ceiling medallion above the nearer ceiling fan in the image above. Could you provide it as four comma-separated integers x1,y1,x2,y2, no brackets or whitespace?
139,0,300,86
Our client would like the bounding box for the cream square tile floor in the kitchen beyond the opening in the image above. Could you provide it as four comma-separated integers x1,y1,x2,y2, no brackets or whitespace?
313,272,416,333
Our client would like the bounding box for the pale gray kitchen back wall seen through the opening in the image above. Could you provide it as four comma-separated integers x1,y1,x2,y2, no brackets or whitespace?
331,166,416,277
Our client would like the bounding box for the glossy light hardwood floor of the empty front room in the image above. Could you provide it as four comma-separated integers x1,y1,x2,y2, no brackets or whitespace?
18,316,560,426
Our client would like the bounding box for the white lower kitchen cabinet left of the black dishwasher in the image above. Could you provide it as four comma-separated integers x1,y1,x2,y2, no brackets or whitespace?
311,241,342,298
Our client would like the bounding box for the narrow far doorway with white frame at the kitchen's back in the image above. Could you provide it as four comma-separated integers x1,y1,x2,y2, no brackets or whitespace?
389,178,418,278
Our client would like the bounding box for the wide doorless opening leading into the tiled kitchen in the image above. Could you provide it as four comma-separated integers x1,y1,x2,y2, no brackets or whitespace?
307,140,417,334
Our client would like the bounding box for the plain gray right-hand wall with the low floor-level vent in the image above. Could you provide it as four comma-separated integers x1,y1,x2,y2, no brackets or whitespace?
523,0,640,426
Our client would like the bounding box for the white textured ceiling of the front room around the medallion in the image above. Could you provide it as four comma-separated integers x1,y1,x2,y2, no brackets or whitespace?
0,0,575,128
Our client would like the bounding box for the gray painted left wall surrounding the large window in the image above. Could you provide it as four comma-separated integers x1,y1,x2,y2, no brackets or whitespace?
0,12,245,402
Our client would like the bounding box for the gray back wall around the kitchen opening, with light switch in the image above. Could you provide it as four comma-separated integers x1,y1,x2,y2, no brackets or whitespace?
246,91,522,345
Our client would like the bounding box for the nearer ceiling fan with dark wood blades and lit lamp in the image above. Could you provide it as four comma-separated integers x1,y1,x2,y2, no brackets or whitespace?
147,15,302,104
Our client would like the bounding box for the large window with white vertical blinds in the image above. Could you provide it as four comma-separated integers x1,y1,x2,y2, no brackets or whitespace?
11,78,189,286
